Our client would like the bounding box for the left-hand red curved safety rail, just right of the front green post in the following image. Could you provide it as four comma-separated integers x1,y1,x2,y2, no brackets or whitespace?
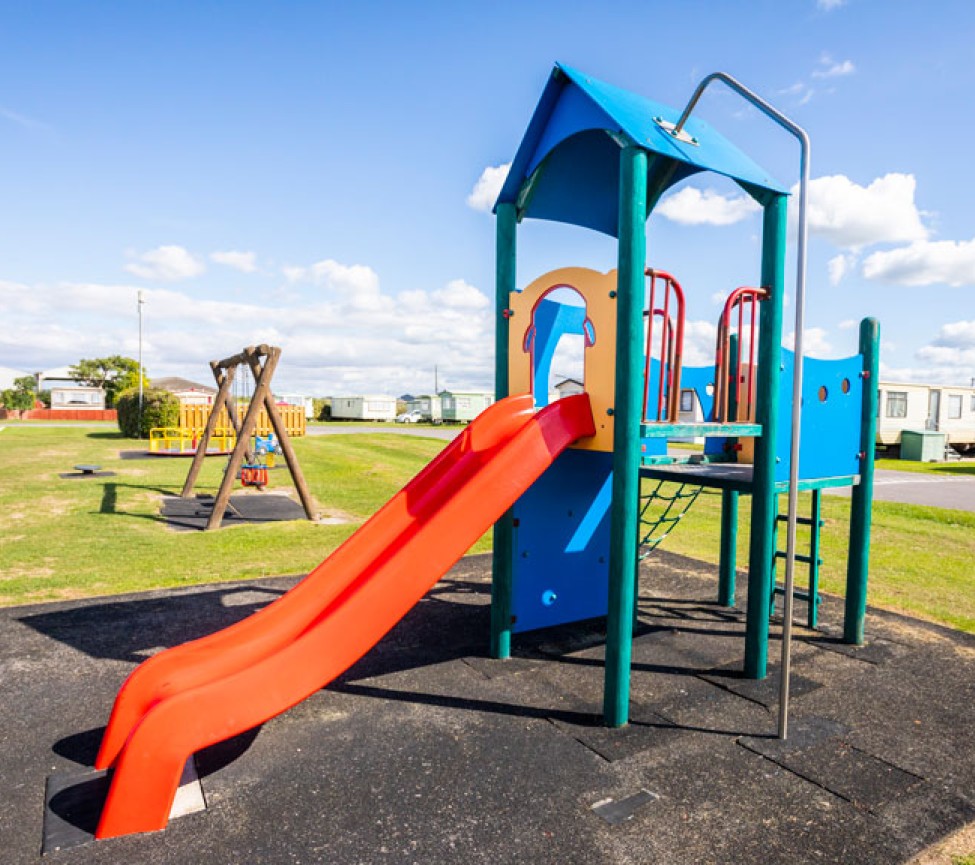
643,267,684,423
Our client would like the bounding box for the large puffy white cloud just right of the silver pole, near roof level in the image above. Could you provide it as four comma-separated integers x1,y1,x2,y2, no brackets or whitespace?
790,174,928,250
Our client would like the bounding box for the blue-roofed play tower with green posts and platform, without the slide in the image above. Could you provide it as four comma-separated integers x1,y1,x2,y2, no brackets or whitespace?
491,65,879,726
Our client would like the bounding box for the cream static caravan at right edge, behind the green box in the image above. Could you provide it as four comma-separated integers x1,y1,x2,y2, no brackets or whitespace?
877,381,975,452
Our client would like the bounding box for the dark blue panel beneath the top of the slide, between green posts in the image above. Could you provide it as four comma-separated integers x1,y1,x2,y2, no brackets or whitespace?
512,448,613,633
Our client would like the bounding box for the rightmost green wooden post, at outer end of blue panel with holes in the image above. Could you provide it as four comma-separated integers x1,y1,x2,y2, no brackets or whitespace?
843,318,880,646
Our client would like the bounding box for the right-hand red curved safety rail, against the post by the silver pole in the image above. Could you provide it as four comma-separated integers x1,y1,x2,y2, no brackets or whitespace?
714,286,768,422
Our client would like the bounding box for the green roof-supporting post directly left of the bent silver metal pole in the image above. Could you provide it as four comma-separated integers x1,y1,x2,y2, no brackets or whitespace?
744,195,786,679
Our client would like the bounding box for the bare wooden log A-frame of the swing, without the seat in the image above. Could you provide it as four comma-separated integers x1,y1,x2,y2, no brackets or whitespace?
180,345,317,530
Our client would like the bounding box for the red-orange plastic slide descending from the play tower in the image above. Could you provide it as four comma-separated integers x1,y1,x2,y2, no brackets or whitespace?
95,394,595,838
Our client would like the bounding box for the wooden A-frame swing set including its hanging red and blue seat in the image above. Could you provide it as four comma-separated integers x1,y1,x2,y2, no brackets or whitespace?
180,345,315,530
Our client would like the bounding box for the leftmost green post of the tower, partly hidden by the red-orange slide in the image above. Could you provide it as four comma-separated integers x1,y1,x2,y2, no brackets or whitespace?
491,204,518,659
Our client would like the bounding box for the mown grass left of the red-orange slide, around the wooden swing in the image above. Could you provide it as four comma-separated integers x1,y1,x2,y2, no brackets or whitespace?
0,426,454,605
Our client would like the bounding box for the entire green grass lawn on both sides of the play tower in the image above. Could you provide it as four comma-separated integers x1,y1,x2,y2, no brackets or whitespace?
0,425,975,632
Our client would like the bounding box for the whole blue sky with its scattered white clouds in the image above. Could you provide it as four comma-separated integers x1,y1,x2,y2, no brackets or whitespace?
0,0,975,395
